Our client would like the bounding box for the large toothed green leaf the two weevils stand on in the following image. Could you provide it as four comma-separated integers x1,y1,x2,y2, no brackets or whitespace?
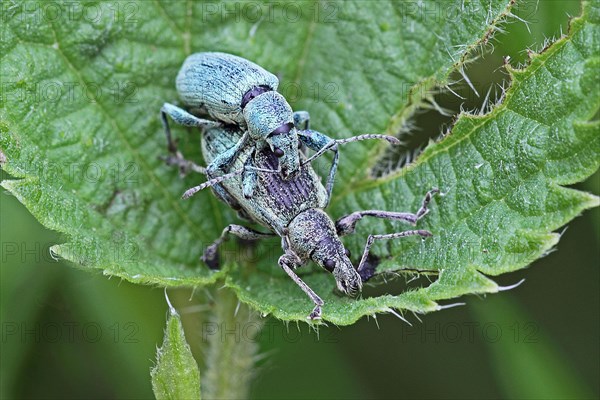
0,0,599,324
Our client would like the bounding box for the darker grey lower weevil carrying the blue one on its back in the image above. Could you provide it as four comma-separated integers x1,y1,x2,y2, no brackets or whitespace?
168,126,437,320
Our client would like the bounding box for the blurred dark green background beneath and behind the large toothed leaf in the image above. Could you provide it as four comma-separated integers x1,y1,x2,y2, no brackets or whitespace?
0,1,600,399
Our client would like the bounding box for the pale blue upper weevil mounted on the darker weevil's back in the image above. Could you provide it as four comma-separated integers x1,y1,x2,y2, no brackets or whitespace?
161,52,400,197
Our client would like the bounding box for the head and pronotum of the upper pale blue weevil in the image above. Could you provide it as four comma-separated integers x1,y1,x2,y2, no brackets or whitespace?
244,91,300,178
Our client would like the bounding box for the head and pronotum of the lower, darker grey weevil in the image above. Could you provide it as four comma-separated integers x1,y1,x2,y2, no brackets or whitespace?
288,208,362,296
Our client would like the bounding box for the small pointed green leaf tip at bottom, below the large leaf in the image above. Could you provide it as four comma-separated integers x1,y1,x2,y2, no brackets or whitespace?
150,307,200,399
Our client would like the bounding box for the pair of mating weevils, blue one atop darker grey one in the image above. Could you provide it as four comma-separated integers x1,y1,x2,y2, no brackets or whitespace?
161,53,437,319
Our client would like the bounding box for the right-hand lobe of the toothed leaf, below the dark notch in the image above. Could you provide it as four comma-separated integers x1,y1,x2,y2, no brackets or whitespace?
227,0,600,324
